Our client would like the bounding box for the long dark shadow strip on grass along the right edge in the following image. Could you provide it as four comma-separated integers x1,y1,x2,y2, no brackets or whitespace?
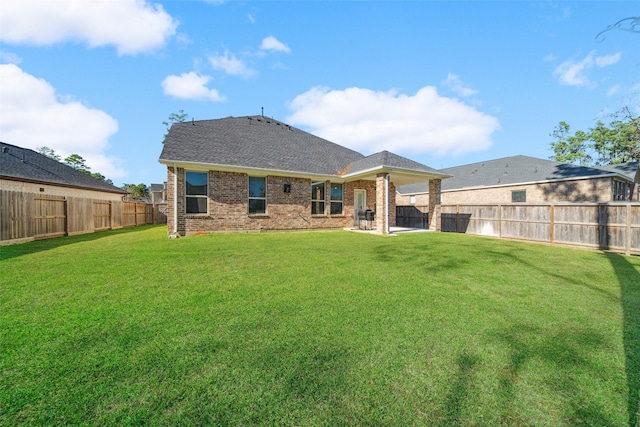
606,253,640,427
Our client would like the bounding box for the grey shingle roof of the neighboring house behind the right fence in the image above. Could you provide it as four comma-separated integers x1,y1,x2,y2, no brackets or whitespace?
396,156,638,194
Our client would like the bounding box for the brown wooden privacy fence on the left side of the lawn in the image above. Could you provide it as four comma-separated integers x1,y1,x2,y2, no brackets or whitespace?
0,190,167,244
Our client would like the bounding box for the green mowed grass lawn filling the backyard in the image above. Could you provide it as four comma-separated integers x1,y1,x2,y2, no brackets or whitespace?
0,226,640,427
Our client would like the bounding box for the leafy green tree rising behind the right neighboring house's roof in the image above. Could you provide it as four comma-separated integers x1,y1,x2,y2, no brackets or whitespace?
550,107,640,166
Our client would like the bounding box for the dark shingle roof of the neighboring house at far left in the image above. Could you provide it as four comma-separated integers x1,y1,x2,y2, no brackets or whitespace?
0,142,126,194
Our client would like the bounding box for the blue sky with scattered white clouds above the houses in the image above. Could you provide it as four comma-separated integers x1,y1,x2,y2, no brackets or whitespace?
0,0,640,186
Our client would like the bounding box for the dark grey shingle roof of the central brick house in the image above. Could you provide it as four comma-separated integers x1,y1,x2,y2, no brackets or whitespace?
159,116,446,182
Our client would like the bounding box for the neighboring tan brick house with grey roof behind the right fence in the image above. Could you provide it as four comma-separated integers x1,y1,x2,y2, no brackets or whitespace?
396,156,640,206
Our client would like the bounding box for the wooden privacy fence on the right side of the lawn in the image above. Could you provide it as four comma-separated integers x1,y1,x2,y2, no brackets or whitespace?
440,203,640,255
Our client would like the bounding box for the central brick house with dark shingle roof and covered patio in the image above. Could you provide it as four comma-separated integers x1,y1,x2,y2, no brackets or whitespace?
159,116,448,235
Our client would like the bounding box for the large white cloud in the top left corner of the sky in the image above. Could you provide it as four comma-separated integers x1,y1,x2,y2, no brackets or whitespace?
0,0,178,55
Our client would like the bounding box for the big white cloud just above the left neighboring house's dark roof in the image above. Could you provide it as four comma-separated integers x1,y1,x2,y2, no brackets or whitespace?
0,64,126,179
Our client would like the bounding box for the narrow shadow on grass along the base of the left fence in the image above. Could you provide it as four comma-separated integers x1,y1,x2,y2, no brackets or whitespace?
0,225,158,261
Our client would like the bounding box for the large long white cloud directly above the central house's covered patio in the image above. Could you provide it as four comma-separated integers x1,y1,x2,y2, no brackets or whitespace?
287,86,500,156
